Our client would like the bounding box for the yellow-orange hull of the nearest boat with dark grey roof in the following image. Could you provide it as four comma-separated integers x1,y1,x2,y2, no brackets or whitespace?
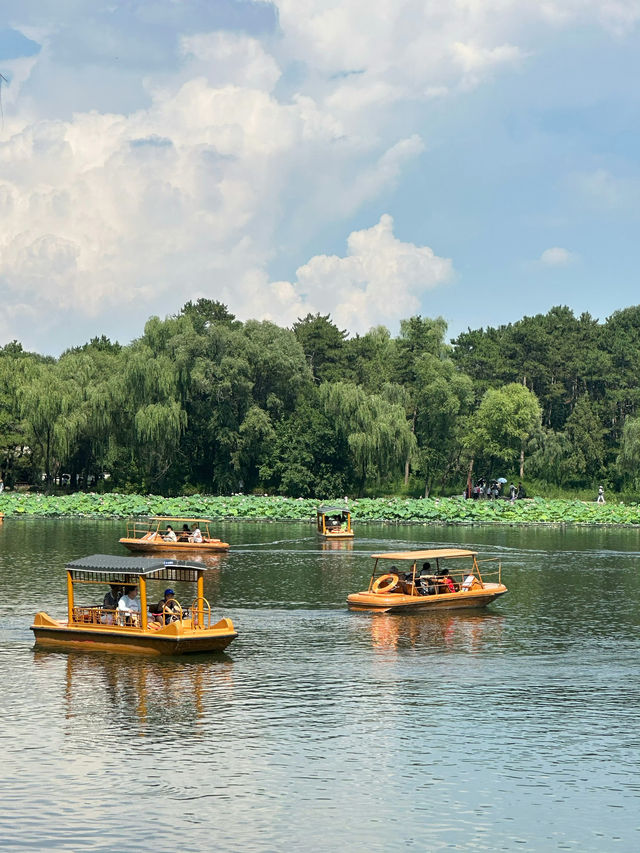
31,613,238,655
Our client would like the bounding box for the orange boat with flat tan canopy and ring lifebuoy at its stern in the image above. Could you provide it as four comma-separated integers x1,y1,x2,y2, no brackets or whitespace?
347,548,507,612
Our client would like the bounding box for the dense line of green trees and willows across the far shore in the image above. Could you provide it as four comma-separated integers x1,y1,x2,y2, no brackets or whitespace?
0,299,640,498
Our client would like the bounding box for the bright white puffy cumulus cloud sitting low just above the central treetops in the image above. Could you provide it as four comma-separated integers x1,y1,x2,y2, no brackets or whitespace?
244,214,453,333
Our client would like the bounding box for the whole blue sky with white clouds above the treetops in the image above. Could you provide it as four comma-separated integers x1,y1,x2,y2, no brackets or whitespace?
0,0,640,355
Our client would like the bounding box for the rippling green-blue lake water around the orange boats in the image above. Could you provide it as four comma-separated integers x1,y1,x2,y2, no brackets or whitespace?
0,519,640,853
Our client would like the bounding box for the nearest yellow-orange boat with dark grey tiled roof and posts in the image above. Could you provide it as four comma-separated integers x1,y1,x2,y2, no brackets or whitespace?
31,554,238,655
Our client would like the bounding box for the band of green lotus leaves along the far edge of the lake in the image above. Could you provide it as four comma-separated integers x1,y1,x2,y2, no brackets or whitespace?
0,492,640,524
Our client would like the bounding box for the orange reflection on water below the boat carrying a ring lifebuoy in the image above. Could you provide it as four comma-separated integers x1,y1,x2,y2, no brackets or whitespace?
370,611,504,654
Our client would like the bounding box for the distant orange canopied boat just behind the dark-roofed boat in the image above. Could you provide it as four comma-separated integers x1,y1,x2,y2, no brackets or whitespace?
119,515,229,554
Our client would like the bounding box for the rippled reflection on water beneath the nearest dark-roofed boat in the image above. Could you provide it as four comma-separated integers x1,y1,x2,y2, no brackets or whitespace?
33,648,234,735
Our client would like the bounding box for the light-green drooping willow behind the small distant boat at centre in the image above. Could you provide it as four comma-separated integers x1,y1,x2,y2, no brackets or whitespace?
320,382,416,492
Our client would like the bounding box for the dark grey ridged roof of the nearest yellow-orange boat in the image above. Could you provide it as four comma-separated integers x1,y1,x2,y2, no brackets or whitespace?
66,554,207,583
